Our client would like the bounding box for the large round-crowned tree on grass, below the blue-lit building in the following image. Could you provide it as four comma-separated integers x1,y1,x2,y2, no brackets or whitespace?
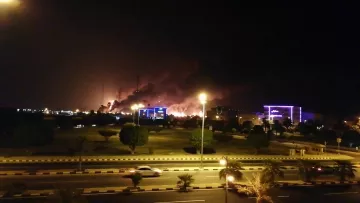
119,123,149,154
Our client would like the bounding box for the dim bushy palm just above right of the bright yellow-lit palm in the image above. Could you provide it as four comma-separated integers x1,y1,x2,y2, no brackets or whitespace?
260,160,284,185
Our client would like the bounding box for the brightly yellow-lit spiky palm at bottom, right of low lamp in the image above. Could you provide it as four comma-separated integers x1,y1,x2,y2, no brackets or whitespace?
238,173,273,203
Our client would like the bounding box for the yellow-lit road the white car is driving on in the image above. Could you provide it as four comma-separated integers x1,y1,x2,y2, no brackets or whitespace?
0,170,298,190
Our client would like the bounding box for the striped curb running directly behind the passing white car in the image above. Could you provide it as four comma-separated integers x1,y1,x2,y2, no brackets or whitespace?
0,167,297,176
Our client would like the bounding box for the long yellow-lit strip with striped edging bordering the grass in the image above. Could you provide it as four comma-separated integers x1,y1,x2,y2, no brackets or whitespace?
0,154,352,164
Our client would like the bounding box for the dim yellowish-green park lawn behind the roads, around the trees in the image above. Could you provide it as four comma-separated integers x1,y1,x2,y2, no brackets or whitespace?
0,127,287,156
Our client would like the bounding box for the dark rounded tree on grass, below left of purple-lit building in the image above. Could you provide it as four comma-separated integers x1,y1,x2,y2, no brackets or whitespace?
247,125,269,154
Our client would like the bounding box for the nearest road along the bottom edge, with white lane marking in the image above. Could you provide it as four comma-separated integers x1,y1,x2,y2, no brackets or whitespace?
2,186,360,203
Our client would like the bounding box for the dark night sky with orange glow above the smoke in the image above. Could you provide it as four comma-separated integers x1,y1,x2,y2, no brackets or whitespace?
0,0,360,115
